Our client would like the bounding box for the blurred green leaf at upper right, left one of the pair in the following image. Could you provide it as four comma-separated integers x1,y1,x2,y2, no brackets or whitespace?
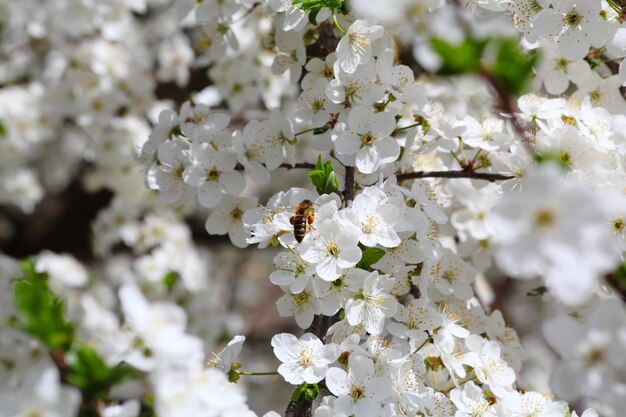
430,38,487,75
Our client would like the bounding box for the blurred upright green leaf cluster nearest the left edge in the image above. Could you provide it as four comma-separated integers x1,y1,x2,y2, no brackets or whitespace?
12,260,74,352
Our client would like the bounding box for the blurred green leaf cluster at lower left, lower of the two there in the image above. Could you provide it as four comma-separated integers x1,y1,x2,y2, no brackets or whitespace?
67,344,139,398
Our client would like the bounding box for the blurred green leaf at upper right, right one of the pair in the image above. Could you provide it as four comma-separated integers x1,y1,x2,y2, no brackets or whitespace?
489,39,539,96
